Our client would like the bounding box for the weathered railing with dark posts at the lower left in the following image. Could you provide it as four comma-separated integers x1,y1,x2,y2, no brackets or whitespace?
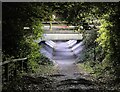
0,58,27,81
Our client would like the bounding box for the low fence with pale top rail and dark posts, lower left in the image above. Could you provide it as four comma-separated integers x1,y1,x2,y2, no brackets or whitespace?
0,58,27,81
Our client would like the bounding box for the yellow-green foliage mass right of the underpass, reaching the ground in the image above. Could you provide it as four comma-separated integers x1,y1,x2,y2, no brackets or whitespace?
73,3,120,79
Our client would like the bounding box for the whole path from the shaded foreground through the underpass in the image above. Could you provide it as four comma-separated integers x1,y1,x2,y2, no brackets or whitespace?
3,42,118,92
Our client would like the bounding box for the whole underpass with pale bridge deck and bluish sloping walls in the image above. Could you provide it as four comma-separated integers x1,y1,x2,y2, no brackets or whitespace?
36,25,83,64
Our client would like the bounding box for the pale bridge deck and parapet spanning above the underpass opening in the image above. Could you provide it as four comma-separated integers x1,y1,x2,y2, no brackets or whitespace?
37,25,83,43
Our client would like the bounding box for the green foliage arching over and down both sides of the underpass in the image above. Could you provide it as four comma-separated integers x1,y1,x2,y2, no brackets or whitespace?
2,2,120,82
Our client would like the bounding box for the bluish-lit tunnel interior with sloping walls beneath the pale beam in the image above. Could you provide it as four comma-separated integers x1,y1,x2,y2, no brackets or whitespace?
39,40,84,65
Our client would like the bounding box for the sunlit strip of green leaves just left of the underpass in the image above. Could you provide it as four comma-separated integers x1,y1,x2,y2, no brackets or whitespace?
25,20,43,71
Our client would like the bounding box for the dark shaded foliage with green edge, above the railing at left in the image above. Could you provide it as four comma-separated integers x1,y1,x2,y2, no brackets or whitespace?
3,3,44,70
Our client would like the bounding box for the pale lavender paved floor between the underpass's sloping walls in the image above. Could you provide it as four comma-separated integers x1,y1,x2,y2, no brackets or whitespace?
53,41,76,66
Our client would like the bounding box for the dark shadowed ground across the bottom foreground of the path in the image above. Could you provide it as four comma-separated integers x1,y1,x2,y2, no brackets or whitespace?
2,69,118,92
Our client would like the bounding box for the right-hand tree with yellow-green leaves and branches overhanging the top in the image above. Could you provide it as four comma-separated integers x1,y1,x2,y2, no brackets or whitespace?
63,2,120,78
